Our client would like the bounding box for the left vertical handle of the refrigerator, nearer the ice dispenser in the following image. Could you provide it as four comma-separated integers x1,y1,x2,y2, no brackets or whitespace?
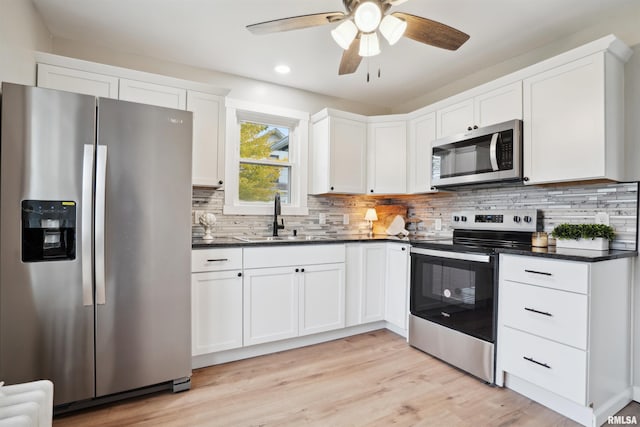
81,144,94,306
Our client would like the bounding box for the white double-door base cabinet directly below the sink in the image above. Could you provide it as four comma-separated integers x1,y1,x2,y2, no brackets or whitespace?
243,244,345,346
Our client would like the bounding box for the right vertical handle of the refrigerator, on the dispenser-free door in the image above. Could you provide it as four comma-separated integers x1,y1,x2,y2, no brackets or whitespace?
95,145,107,304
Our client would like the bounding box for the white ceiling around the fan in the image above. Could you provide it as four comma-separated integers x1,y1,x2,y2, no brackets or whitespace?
32,0,638,107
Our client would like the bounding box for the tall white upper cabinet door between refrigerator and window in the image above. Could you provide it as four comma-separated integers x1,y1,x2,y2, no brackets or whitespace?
187,90,224,187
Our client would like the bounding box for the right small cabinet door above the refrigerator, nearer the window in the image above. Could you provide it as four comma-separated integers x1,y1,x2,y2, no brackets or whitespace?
120,79,187,110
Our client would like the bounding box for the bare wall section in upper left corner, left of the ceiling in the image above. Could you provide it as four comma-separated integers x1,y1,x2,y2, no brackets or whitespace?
0,0,52,89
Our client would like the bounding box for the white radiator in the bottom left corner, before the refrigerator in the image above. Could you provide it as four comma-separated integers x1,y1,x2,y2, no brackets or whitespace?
0,380,53,427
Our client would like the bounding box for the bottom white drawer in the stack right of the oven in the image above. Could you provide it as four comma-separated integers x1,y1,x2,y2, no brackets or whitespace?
498,327,587,405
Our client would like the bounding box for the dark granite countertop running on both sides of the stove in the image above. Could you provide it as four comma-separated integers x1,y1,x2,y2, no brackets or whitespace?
191,234,638,262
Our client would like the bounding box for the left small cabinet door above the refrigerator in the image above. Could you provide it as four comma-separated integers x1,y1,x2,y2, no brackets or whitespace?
38,64,118,99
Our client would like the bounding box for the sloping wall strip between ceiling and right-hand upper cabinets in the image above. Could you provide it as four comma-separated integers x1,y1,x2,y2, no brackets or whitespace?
392,1,640,113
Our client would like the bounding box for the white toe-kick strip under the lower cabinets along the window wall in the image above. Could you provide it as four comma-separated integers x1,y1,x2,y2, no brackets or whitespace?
191,321,384,369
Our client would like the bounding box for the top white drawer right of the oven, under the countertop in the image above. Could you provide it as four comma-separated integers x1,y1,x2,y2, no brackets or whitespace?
500,255,589,294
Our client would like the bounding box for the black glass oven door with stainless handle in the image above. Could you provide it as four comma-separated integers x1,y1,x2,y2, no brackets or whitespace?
410,248,495,342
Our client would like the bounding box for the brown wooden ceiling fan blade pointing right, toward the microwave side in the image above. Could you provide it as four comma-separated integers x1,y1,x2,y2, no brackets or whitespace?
392,12,469,50
